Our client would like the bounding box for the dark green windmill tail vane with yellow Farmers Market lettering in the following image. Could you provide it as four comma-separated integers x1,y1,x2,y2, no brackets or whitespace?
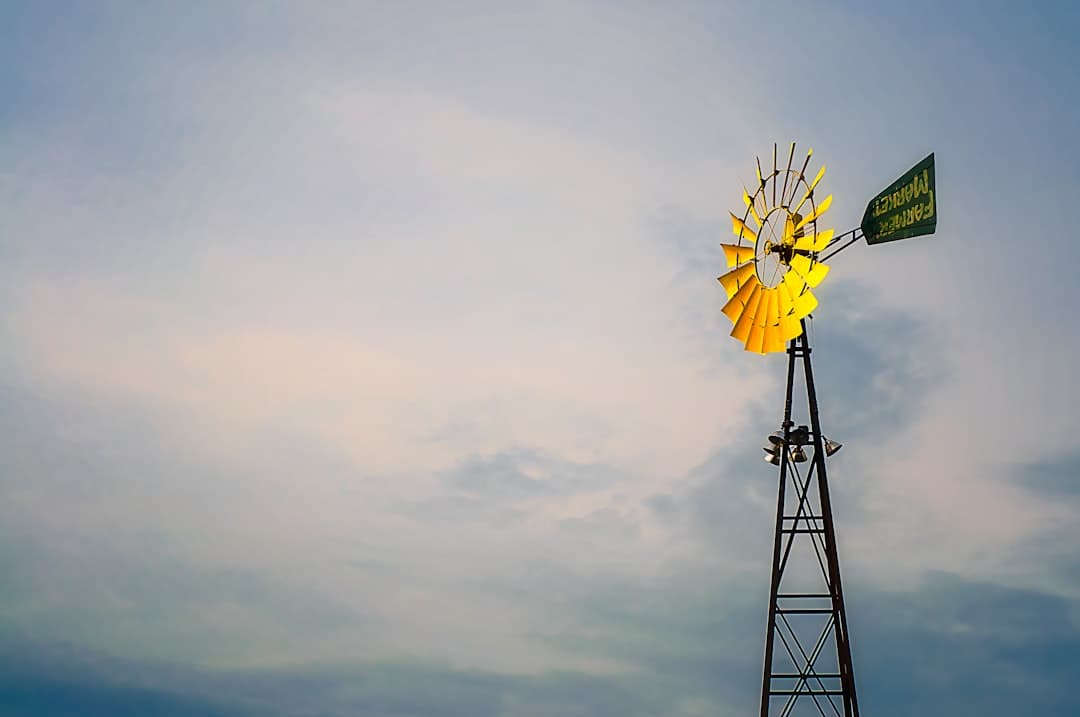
861,152,937,244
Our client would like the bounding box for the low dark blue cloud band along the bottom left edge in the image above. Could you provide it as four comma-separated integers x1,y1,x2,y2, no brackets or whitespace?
0,642,686,717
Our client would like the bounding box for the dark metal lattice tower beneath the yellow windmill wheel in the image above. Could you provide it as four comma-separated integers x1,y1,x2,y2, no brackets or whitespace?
760,325,859,717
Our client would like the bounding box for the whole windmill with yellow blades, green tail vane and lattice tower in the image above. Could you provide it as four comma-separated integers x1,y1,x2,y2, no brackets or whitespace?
719,143,937,717
